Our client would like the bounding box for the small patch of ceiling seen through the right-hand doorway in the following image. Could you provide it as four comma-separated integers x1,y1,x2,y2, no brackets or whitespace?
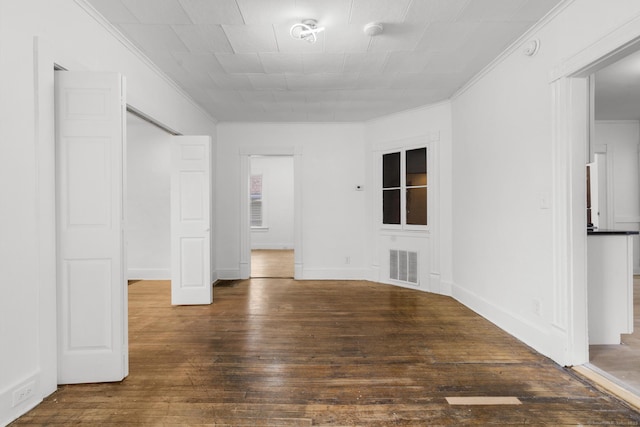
595,51,640,120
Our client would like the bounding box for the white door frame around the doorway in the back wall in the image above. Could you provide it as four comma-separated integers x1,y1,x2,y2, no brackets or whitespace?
238,147,304,280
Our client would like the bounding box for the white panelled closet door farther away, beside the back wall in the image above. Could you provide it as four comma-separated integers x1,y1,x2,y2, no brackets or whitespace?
171,136,213,305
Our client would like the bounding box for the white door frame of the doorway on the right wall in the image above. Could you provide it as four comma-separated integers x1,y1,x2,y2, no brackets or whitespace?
549,16,640,366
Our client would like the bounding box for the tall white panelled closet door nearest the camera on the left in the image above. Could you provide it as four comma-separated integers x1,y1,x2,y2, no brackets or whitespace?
55,71,129,384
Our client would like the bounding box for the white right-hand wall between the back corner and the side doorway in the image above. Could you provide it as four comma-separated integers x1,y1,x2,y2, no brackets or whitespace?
452,0,640,364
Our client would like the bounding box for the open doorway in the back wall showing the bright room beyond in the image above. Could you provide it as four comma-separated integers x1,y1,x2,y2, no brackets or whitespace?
249,155,295,278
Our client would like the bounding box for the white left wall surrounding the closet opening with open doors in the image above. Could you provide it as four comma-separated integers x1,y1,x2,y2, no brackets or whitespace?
0,0,216,424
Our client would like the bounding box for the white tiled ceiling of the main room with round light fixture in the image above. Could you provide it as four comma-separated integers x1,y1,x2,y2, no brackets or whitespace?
88,0,561,122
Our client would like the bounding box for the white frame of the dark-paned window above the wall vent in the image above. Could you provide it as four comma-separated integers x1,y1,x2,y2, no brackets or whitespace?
378,143,432,232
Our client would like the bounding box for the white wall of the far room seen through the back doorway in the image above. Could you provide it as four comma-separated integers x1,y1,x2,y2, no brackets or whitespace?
250,156,294,249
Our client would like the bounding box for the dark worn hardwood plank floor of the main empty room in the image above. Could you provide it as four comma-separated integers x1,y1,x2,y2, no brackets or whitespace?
14,279,640,426
